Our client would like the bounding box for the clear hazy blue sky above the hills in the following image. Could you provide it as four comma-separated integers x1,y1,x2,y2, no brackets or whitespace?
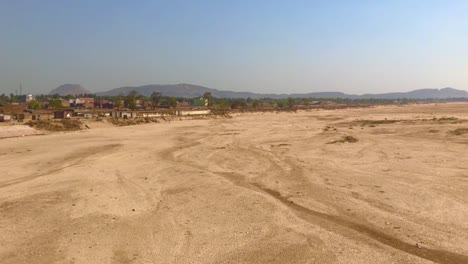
0,0,468,94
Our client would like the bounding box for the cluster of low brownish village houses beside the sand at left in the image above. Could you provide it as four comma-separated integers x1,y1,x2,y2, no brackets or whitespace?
0,95,210,122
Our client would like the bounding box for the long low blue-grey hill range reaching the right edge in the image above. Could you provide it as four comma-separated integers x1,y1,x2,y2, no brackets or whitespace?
96,83,468,99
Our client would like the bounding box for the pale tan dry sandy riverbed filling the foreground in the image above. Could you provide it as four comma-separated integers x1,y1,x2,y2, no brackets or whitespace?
0,103,468,264
